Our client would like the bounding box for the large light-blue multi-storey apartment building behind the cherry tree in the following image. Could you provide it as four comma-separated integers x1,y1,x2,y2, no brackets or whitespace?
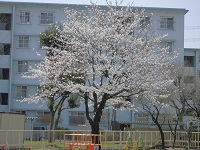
0,1,187,129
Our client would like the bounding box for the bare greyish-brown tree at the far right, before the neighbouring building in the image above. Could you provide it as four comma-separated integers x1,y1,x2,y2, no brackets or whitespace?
168,62,200,147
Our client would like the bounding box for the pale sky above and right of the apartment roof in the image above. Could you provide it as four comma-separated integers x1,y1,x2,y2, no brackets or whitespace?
3,0,200,49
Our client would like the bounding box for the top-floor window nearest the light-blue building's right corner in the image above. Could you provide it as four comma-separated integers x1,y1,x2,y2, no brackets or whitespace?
160,17,174,29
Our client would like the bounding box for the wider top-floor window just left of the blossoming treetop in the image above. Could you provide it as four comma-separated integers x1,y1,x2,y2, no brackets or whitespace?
40,12,54,24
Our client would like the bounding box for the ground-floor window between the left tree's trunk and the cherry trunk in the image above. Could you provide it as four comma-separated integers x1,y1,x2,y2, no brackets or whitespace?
69,112,85,126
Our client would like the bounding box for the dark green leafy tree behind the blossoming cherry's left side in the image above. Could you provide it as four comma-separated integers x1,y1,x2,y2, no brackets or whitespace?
23,23,84,142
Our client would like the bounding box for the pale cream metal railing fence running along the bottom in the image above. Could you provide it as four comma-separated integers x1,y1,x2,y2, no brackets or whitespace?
0,130,200,150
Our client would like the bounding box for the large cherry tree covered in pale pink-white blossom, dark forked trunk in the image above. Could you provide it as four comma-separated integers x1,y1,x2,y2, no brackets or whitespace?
24,1,175,145
